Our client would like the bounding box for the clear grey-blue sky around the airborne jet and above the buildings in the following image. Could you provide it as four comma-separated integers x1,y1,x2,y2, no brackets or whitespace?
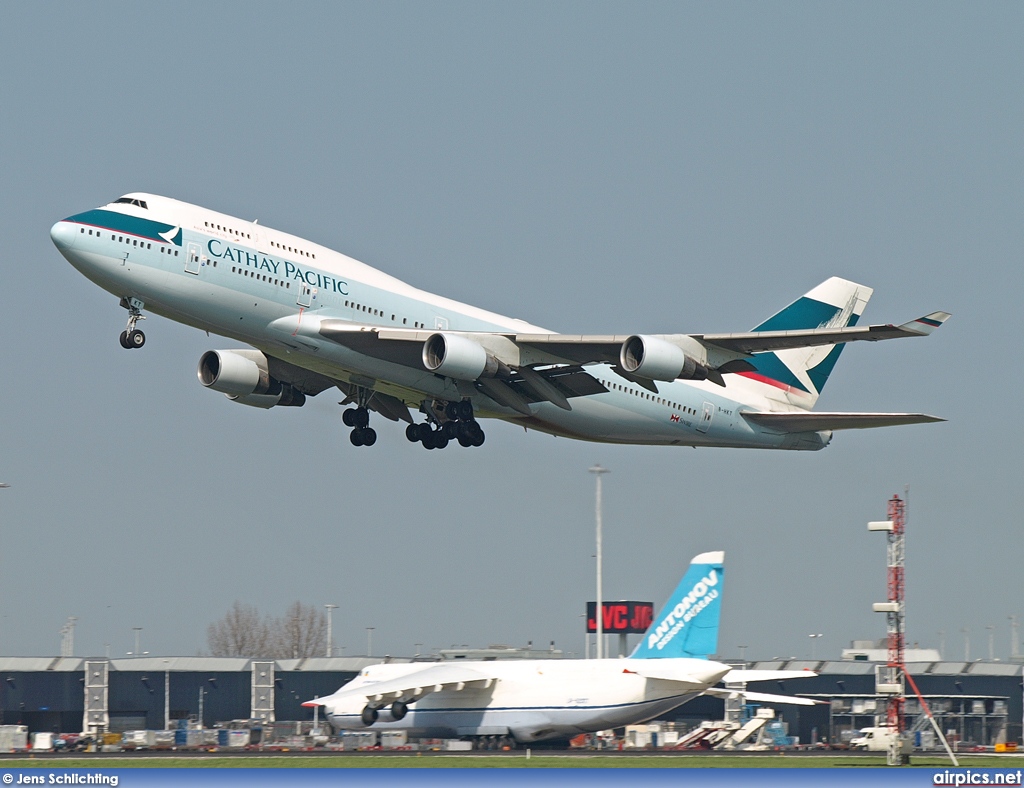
0,2,1024,657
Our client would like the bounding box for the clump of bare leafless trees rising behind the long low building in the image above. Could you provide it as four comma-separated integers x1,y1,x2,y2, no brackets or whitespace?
206,601,327,659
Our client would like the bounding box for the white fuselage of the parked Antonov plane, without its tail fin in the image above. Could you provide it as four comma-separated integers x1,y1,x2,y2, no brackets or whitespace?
306,658,731,742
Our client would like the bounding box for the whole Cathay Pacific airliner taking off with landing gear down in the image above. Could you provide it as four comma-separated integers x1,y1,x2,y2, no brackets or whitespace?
50,193,949,450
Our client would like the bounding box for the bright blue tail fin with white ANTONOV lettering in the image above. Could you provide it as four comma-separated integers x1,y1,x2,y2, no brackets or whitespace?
630,552,725,659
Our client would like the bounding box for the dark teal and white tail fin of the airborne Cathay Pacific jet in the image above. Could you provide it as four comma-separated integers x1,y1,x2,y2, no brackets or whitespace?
743,276,872,409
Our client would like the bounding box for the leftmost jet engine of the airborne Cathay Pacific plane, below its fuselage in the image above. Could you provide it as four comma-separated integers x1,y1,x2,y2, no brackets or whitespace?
196,350,306,408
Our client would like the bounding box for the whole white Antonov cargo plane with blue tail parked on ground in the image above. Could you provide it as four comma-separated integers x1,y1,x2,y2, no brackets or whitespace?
302,553,816,744
